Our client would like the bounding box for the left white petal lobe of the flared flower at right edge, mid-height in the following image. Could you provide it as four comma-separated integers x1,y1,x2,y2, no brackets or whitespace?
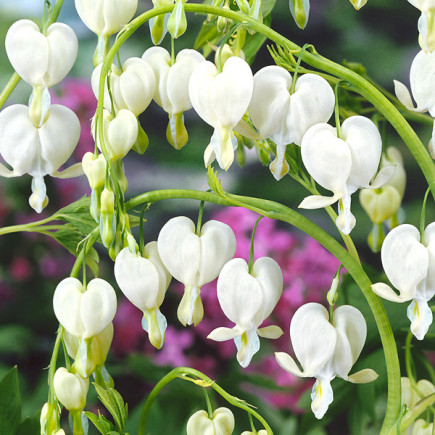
381,224,429,300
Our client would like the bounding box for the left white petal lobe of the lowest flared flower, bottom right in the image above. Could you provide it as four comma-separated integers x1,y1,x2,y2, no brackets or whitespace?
290,303,337,376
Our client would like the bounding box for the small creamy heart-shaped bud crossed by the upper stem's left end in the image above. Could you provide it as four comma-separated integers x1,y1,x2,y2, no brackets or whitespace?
92,109,139,161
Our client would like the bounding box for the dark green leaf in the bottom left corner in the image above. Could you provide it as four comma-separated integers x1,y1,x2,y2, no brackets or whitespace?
0,367,21,435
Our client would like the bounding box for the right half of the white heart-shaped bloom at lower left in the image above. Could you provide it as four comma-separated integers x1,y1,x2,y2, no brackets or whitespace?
80,278,116,339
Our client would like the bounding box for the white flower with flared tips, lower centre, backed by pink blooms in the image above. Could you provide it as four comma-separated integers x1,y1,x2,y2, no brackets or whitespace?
207,257,283,367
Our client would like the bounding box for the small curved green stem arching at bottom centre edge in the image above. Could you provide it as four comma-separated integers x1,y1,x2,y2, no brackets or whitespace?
138,367,273,435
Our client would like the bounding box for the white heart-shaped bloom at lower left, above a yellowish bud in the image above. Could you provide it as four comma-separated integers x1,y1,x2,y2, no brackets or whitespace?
53,277,116,340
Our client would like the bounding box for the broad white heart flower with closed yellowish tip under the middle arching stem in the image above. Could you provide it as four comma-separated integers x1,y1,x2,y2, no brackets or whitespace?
157,216,236,326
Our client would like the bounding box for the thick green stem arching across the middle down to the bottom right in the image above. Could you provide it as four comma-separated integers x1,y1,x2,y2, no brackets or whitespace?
126,189,401,434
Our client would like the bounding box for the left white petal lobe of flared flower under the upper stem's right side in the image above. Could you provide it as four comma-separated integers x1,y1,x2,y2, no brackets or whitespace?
301,124,352,195
